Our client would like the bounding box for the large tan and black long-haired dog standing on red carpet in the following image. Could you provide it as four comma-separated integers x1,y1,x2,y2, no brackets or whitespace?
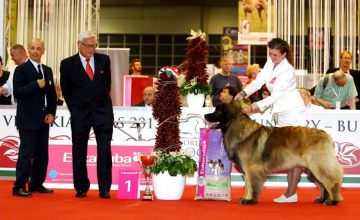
205,101,343,205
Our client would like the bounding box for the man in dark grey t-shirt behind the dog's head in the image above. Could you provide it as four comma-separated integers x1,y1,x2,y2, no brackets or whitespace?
210,57,242,107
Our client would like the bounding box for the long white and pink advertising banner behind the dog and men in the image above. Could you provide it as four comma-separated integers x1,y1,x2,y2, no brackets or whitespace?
0,107,360,187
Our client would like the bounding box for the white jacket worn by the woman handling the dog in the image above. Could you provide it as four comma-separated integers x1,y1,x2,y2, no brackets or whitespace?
244,58,305,113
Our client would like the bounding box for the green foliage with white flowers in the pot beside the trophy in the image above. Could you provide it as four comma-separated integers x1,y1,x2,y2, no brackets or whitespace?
150,151,196,176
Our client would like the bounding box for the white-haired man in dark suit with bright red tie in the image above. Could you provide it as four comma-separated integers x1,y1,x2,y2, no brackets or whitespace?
60,32,114,198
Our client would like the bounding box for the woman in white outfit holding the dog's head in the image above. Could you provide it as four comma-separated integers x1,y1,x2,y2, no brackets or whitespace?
235,38,306,203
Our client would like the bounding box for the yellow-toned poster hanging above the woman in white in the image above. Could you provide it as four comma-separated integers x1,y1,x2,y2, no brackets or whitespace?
238,0,274,45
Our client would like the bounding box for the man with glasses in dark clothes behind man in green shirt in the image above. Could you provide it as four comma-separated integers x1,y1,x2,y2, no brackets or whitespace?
310,50,360,110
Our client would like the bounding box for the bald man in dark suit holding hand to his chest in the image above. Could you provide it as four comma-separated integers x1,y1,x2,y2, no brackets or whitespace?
13,39,56,197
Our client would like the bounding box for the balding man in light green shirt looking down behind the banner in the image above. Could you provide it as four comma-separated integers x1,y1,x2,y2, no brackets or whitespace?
314,70,358,110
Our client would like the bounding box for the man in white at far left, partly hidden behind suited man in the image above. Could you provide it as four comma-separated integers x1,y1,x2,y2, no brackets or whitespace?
0,44,28,105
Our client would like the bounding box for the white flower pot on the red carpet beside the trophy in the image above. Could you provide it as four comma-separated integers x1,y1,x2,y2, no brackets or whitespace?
152,172,185,200
